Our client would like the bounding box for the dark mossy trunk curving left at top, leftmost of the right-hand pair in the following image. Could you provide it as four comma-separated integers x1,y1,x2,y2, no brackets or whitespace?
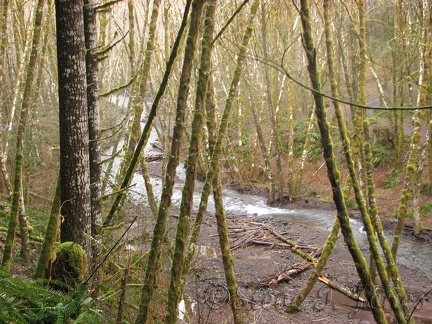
300,0,387,323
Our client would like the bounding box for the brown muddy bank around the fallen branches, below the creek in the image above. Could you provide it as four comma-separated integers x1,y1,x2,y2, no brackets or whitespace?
185,210,432,323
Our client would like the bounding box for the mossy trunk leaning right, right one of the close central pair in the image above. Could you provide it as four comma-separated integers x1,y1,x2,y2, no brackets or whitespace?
166,1,216,323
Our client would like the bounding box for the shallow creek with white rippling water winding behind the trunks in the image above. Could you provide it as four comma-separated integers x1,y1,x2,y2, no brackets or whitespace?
106,96,432,273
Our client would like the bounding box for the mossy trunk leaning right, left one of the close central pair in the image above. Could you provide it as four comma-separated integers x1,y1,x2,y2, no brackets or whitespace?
136,0,205,323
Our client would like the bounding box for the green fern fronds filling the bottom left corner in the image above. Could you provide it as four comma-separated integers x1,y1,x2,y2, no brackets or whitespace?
0,270,102,324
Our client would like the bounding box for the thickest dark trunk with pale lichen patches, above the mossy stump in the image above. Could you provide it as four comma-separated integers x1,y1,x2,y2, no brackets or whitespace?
55,0,91,251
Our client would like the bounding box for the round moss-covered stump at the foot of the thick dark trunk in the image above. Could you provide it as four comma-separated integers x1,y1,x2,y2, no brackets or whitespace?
52,242,87,286
